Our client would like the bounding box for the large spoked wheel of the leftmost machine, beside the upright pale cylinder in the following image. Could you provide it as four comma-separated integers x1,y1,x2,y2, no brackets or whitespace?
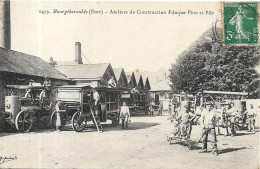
15,111,34,132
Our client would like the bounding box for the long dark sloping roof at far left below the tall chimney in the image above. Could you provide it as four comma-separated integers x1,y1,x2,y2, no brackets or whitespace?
0,48,69,80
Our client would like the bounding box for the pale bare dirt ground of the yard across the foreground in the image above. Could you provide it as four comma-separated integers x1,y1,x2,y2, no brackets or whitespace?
0,113,259,169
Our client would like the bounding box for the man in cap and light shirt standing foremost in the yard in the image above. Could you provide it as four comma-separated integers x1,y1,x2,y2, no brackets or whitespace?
201,102,218,155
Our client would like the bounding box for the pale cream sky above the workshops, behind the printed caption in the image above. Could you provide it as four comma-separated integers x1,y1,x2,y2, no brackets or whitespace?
11,0,221,71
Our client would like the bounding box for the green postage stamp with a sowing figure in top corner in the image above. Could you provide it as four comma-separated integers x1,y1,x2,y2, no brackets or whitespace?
222,2,259,45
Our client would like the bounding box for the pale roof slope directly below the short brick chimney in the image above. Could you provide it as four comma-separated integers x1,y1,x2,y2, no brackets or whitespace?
56,63,111,79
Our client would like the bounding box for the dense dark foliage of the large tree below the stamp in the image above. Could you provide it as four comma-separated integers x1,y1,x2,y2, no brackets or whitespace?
170,30,260,97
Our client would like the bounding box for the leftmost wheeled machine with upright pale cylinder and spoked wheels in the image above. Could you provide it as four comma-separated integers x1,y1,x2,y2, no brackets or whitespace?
4,85,53,132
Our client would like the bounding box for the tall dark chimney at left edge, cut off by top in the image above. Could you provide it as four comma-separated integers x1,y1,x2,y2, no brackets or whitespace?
0,0,11,49
